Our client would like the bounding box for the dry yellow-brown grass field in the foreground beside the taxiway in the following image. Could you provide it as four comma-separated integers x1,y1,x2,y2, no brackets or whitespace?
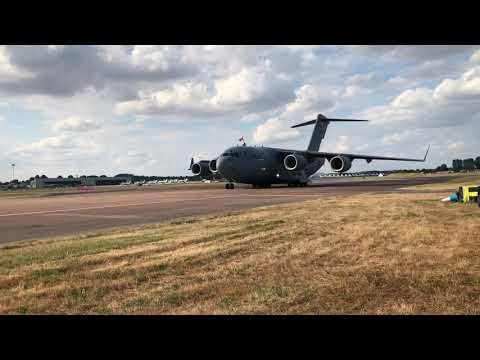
0,184,480,314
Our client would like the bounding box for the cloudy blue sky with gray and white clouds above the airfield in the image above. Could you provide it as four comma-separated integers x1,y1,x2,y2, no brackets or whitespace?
0,45,480,181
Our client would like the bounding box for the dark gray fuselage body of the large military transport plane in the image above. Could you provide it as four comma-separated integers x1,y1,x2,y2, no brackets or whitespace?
216,146,325,184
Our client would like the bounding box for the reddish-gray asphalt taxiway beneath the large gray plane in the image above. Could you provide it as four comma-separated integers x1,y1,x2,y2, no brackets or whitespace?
0,177,449,243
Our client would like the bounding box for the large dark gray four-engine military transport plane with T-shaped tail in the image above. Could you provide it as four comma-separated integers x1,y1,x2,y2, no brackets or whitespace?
189,114,430,189
